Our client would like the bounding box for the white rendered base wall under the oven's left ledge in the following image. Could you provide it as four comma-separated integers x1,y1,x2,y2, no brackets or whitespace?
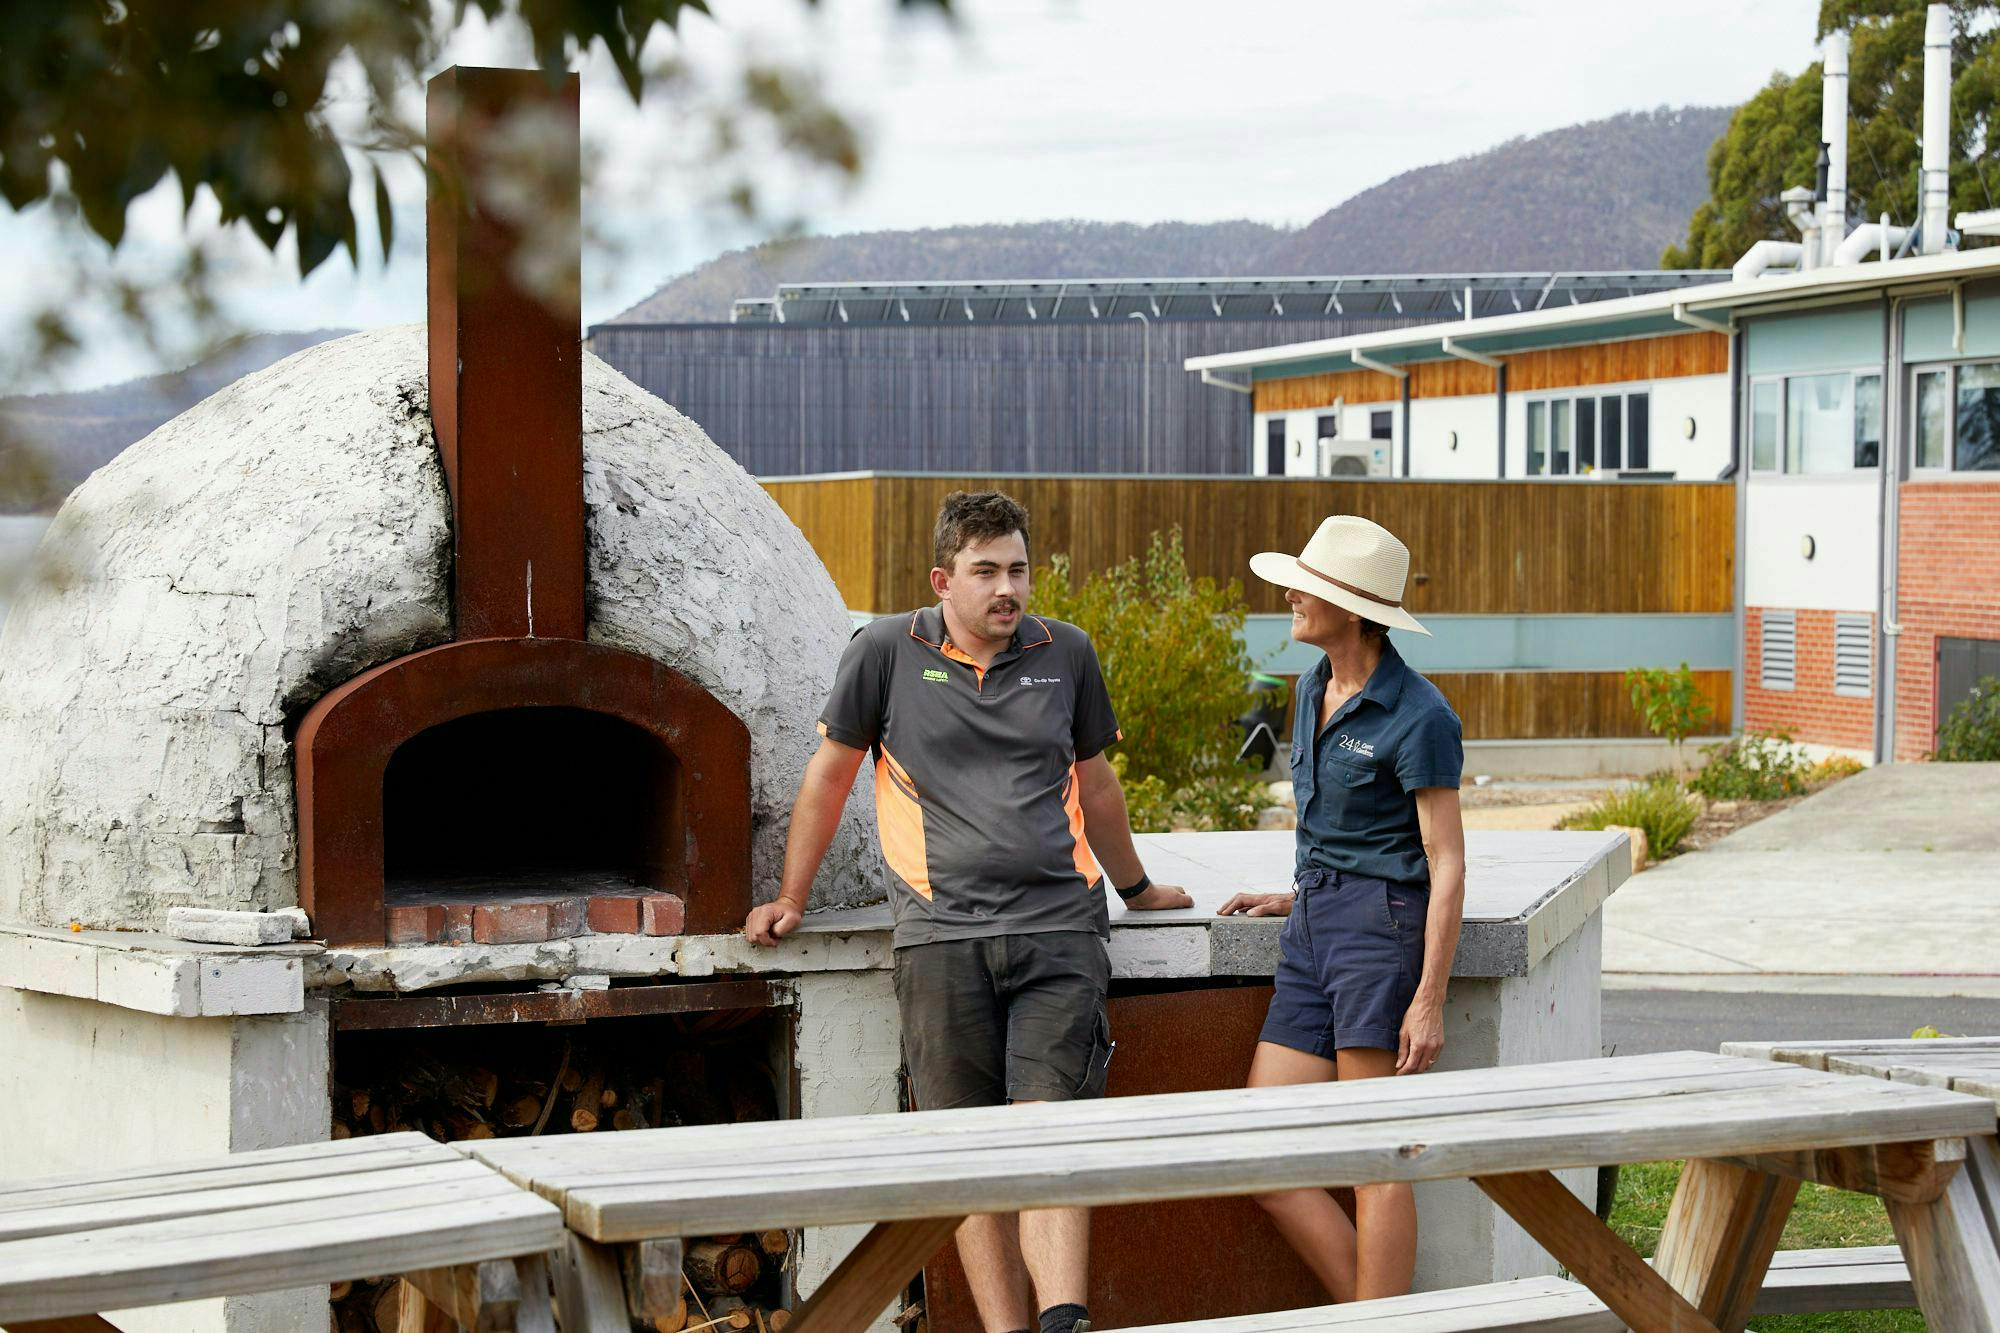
0,989,330,1333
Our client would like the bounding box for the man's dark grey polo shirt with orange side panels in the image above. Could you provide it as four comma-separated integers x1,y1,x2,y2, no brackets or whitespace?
820,606,1118,949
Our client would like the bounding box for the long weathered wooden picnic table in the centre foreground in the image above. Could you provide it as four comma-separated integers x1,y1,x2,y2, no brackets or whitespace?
454,1051,1994,1333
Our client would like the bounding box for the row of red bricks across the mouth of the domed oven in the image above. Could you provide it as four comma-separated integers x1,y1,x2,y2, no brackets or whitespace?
382,871,688,945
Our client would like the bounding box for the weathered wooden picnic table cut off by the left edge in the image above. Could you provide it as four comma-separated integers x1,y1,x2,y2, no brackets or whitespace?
0,1133,564,1333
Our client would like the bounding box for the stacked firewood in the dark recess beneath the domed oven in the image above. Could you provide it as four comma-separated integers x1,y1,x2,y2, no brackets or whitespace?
332,1015,792,1333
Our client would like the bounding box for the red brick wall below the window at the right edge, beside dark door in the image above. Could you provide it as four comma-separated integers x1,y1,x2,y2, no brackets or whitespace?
1896,478,2000,759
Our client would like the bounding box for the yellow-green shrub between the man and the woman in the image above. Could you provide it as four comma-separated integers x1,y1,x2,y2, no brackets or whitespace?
1030,528,1250,784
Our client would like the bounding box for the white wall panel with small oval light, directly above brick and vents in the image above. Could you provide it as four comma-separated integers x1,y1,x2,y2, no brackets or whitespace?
1742,468,1882,610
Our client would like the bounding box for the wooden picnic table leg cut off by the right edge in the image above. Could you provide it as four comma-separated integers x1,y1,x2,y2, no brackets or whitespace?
1888,1137,2000,1333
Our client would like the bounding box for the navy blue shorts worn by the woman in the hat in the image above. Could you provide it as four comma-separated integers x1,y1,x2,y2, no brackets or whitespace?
1260,871,1430,1061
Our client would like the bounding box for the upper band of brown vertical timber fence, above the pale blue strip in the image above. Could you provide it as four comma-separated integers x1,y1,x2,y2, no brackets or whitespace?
764,474,1736,616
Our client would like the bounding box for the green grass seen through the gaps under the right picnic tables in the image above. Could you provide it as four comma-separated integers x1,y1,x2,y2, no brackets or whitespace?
1612,1161,1924,1333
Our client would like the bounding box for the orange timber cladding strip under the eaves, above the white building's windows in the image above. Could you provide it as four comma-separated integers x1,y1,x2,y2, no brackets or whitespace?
1252,332,1730,412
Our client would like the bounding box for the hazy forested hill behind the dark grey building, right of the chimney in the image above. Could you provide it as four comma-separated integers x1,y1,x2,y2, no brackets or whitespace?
614,106,1730,324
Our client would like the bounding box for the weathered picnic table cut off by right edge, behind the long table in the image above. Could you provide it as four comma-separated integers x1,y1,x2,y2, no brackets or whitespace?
1722,1037,2000,1329
